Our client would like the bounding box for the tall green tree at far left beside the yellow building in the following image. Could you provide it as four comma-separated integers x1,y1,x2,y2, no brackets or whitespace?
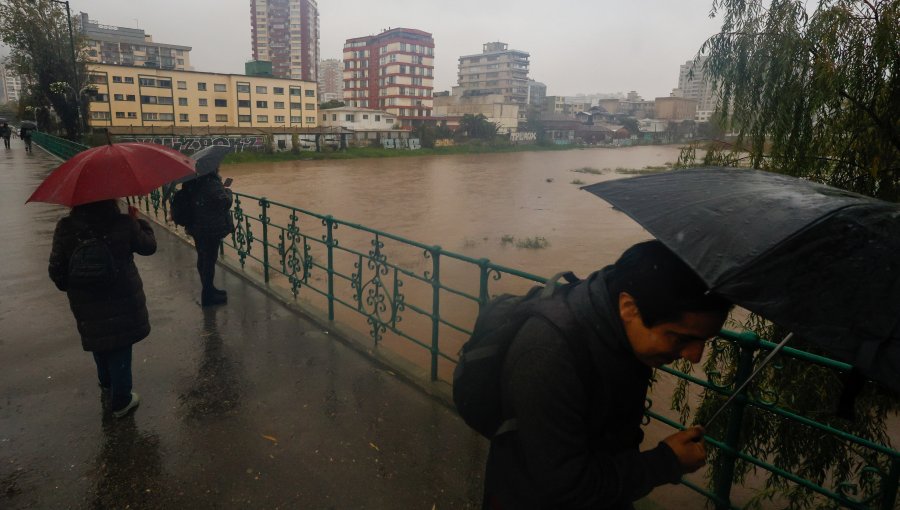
0,0,87,139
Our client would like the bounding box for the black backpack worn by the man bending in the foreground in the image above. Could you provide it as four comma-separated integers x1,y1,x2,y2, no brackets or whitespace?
453,272,592,439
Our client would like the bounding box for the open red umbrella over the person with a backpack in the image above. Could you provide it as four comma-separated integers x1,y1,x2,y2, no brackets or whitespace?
26,143,195,207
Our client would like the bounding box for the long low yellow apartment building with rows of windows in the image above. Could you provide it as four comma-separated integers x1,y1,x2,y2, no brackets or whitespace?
88,64,319,128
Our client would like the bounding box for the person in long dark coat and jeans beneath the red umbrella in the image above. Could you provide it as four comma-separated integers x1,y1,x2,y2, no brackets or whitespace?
49,200,156,418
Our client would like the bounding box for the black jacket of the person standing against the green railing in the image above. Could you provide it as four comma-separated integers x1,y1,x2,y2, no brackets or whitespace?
184,173,234,239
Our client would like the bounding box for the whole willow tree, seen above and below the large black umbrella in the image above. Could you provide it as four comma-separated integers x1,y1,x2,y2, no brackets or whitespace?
673,0,900,508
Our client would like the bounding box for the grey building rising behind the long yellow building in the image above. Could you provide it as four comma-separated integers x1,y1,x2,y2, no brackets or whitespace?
78,12,193,71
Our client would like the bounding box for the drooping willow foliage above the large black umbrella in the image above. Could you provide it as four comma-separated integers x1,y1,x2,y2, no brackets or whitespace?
701,0,900,201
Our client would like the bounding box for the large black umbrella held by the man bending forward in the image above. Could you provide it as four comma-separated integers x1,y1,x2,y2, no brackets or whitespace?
584,168,900,391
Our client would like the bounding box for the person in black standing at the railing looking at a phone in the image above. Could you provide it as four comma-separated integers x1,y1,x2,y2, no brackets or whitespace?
183,169,234,306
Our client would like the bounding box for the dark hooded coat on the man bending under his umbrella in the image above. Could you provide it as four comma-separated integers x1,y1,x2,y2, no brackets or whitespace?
484,268,681,510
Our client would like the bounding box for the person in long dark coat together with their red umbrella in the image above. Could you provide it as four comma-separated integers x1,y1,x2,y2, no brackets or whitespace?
28,143,195,418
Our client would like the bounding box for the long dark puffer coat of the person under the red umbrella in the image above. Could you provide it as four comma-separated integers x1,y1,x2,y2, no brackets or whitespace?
49,203,156,352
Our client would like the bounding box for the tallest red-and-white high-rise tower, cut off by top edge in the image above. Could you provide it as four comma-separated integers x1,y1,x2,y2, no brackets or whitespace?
250,0,319,81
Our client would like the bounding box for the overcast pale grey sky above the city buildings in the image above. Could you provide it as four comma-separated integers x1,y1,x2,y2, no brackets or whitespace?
70,0,719,99
